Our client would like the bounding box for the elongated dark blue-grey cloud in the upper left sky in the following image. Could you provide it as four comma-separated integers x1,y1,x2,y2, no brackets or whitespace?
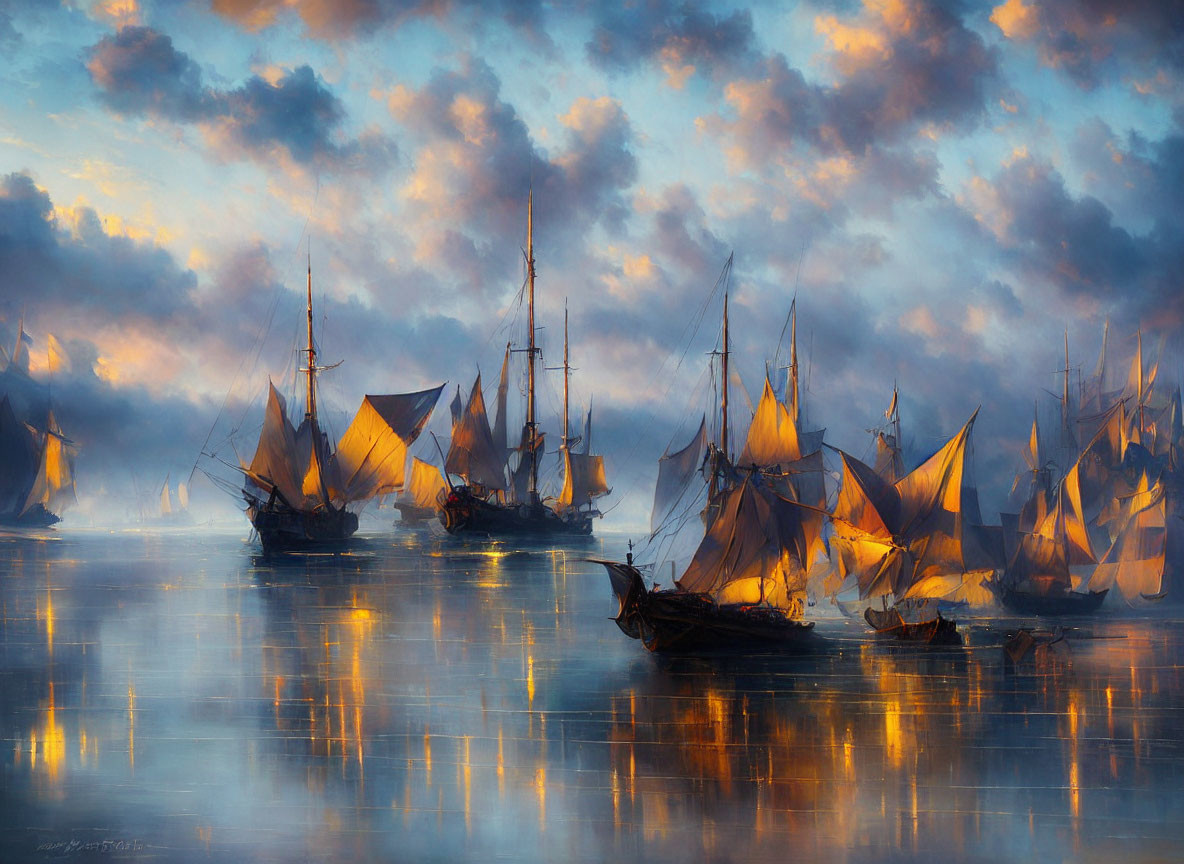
86,26,394,169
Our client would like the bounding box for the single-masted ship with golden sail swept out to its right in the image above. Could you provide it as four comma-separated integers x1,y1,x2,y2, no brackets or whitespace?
239,264,444,552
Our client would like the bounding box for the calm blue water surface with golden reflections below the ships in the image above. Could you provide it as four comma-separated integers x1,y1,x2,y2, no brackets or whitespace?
0,530,1184,862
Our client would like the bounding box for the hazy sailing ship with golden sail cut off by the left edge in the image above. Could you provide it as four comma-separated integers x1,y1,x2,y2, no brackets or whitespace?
0,395,77,528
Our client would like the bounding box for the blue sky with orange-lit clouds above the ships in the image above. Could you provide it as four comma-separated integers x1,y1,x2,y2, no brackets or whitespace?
0,0,1184,530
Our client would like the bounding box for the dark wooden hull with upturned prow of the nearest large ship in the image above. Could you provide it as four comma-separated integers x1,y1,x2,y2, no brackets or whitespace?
600,561,817,652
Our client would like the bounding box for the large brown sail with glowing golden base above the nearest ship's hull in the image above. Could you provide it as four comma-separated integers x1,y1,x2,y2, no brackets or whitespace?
678,479,806,614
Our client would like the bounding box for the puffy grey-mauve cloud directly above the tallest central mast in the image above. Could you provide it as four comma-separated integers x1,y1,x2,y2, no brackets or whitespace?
375,57,637,291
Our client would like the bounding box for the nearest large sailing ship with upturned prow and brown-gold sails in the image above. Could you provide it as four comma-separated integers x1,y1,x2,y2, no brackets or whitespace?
600,257,824,651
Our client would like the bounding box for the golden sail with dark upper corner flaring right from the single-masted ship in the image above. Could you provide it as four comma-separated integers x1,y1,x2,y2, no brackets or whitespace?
333,385,444,502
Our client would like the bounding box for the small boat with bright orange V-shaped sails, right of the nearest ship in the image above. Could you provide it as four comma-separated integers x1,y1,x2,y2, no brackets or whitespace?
831,411,991,643
